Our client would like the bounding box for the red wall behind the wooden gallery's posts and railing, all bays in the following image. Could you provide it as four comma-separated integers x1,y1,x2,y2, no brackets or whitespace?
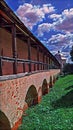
0,29,46,75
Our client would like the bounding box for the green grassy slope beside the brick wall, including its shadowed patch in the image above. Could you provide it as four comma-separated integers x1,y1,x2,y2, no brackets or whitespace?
19,75,73,130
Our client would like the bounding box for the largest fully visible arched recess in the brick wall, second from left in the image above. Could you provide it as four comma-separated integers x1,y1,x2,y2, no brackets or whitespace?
25,85,38,107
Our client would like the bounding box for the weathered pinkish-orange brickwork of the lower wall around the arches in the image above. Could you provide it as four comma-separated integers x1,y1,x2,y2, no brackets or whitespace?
0,70,60,130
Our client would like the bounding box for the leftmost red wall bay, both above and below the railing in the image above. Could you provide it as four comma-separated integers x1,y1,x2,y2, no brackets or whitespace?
0,29,13,75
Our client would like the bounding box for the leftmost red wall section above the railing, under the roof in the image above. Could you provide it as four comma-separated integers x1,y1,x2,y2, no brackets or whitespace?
0,29,12,57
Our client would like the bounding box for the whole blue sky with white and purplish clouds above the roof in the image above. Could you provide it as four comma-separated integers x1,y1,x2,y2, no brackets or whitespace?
5,0,73,57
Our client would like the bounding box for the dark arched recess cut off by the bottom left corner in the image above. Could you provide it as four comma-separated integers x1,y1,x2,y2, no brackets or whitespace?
0,111,11,130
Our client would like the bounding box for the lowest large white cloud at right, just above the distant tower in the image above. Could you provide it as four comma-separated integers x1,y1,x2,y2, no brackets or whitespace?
46,33,73,57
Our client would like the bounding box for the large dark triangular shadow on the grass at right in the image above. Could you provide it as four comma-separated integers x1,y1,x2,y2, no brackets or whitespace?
51,89,73,109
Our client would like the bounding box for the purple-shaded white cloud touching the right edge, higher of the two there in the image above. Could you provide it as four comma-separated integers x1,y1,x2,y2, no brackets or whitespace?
55,8,73,33
